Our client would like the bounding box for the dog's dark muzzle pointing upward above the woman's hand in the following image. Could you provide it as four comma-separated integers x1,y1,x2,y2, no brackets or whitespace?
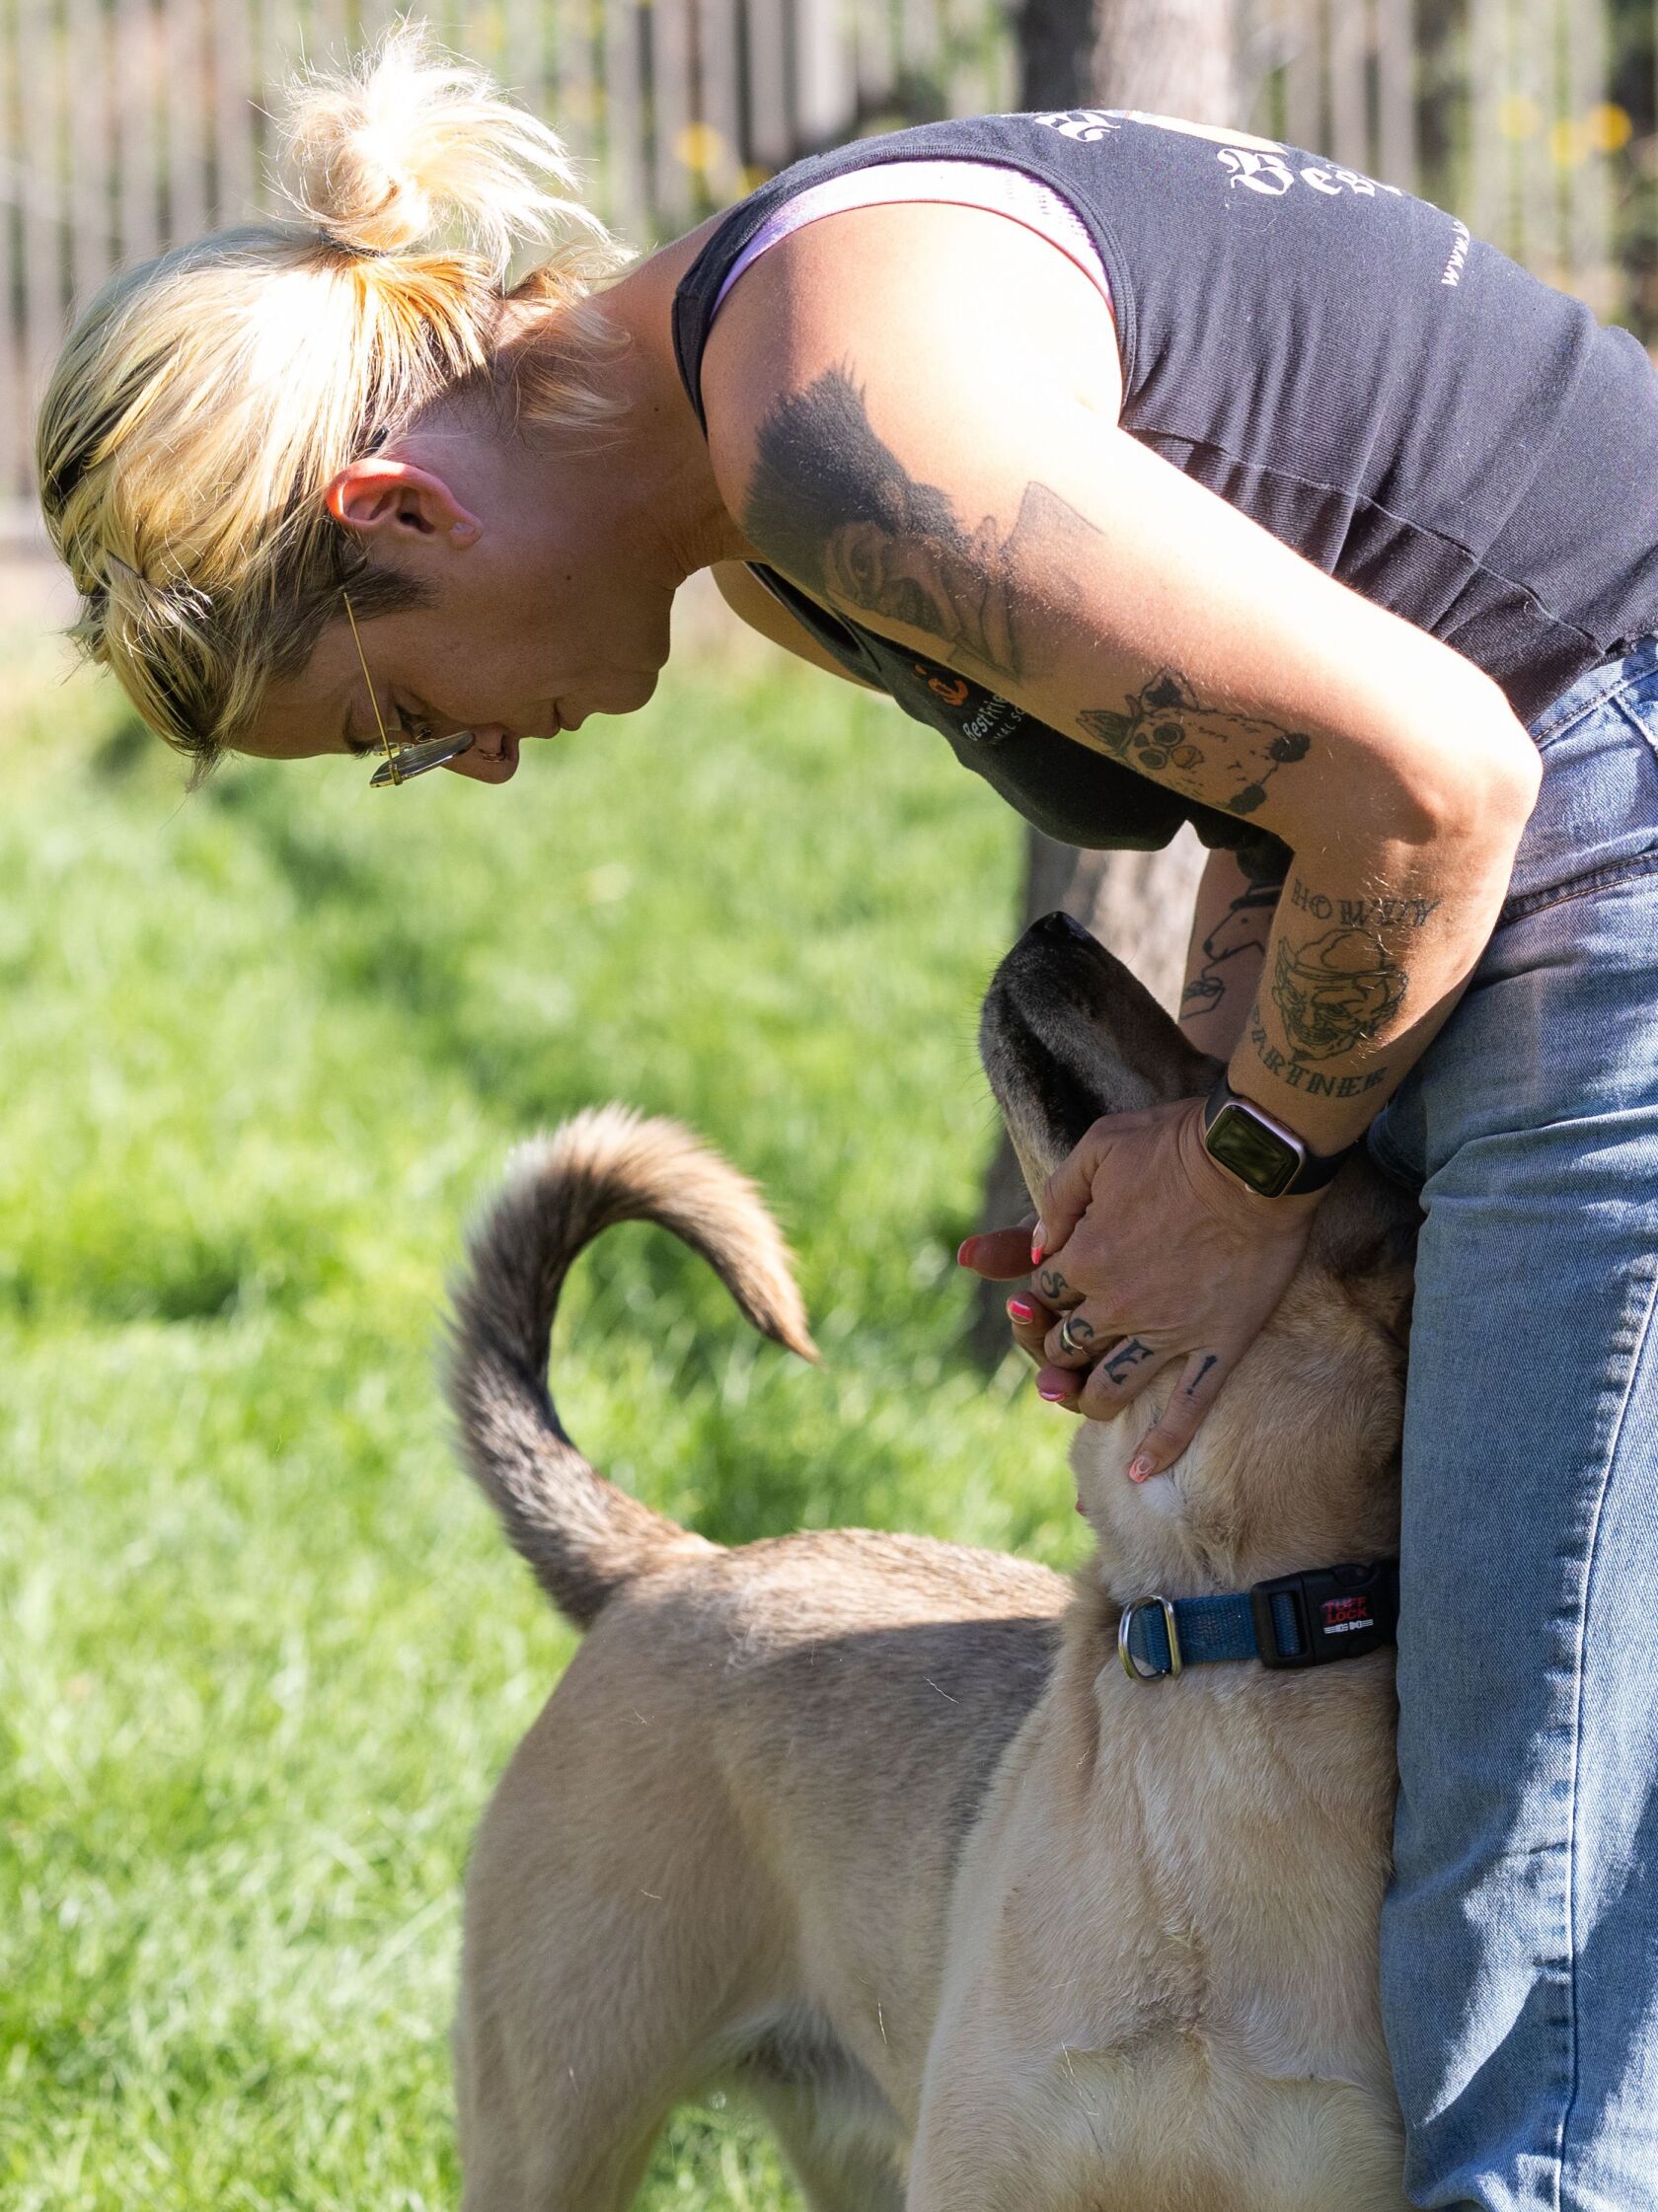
978,914,1220,1190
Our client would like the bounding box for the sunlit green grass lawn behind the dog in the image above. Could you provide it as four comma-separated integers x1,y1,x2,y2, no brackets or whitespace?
0,615,1076,2212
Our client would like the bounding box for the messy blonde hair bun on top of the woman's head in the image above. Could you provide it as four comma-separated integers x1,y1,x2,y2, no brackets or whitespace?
283,22,602,276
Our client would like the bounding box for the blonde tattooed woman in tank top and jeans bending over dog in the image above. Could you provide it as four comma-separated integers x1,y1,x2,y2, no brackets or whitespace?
39,21,1658,2212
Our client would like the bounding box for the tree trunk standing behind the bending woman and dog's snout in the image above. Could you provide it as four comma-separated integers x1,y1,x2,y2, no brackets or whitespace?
969,0,1242,1364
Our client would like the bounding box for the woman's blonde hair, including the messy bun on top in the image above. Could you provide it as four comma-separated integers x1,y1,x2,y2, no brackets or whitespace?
36,22,627,776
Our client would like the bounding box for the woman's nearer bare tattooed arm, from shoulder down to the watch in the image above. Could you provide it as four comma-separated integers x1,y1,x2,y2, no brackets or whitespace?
704,206,1541,1152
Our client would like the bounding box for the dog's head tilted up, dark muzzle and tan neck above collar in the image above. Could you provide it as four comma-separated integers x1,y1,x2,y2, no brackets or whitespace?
981,914,1419,1597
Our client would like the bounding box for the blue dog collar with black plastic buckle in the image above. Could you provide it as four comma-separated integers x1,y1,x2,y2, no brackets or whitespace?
1118,1560,1399,1681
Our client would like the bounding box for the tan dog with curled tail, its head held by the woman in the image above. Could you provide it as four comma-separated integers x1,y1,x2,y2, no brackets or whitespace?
452,921,1414,2212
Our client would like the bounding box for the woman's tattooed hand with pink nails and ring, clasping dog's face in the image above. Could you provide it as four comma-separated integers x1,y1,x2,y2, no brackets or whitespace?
960,1099,1321,1482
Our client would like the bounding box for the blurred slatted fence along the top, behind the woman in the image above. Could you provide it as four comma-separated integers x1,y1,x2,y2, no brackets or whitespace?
0,0,1658,536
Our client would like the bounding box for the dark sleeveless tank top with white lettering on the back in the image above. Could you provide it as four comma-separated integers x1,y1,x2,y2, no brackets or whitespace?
675,109,1658,851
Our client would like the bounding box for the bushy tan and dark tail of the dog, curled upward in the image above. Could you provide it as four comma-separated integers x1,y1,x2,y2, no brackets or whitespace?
449,1106,817,1628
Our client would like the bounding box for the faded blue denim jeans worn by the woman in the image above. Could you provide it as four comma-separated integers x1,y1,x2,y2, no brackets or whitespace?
1370,639,1658,2212
